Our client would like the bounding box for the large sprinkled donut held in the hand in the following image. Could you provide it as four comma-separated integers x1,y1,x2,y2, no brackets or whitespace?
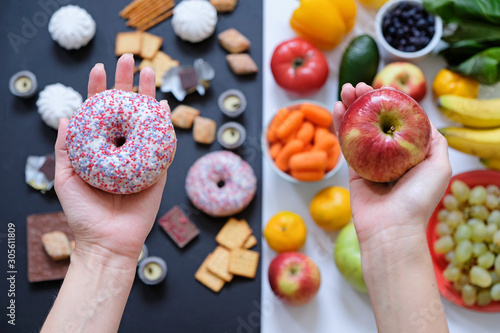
66,90,177,194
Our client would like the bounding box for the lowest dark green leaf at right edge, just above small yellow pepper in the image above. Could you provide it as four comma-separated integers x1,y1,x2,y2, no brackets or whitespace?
451,47,500,84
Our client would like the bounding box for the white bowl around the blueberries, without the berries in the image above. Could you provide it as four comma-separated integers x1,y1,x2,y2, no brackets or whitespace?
375,0,443,61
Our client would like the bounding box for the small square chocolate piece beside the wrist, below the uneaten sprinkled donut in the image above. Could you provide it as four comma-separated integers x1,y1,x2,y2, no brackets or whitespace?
158,206,200,249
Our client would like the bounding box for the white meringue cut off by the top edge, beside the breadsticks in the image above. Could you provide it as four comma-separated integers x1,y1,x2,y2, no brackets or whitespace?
172,0,217,43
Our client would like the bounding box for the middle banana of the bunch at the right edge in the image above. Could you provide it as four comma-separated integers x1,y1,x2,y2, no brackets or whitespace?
439,127,500,159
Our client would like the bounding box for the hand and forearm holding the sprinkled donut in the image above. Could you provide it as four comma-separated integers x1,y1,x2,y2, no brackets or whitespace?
42,55,169,332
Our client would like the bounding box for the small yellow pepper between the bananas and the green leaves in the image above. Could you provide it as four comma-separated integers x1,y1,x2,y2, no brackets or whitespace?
432,68,479,98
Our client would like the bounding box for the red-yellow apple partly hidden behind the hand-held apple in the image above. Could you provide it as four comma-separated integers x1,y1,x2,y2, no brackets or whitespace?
373,61,427,102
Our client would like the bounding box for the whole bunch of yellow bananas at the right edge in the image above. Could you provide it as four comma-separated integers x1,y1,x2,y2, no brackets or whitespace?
438,95,500,170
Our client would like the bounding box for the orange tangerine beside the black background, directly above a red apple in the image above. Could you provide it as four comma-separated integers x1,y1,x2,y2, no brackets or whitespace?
264,211,307,252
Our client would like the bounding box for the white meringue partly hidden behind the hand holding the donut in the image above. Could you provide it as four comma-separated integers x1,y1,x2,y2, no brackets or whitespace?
36,83,83,129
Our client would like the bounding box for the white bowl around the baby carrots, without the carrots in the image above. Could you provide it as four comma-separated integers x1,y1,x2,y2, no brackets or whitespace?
260,100,345,184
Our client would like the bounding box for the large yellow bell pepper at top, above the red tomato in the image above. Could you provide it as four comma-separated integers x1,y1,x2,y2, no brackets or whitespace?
290,0,356,50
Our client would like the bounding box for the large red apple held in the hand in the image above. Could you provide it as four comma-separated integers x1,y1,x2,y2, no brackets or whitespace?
339,88,431,183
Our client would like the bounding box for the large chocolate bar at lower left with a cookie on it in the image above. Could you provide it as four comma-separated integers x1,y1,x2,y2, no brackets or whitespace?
26,212,75,282
